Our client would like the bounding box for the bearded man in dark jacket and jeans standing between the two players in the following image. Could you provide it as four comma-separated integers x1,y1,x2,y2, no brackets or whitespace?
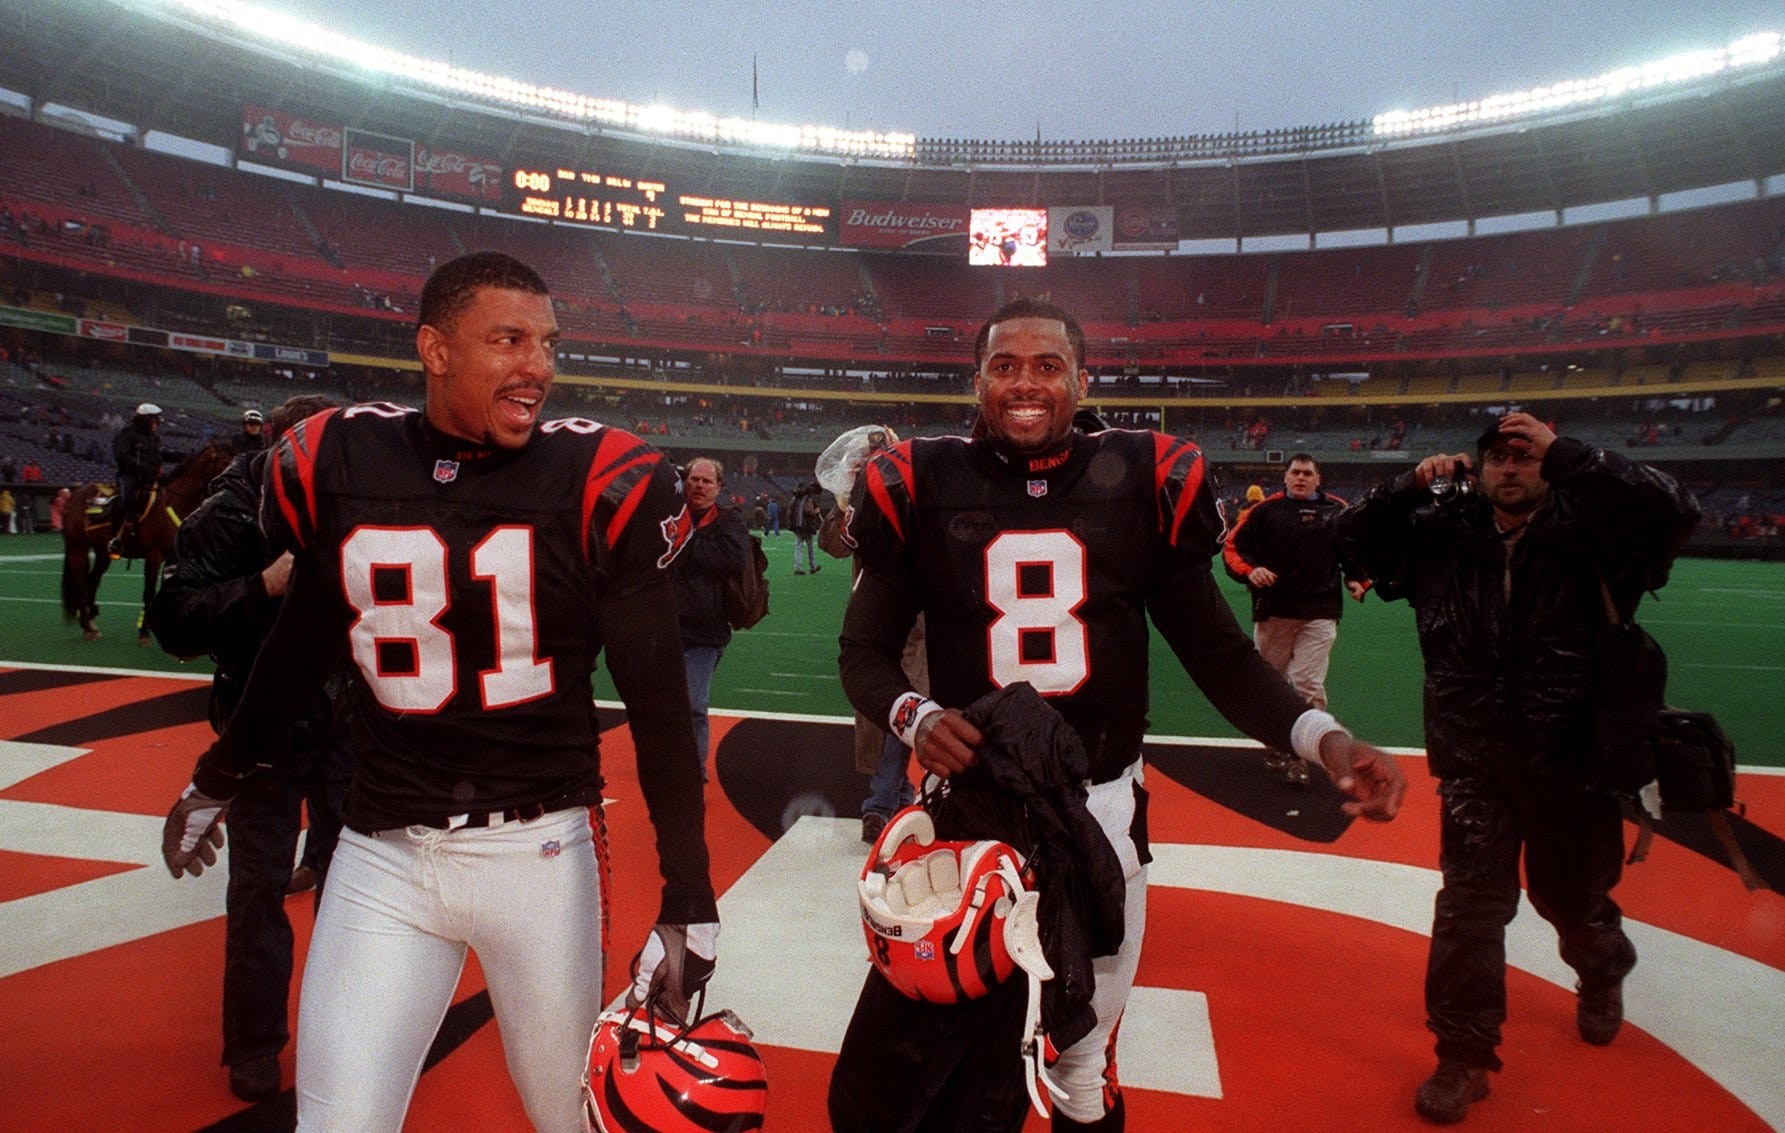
671,457,750,782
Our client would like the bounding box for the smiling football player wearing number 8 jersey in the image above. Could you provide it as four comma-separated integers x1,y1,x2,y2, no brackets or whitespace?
830,300,1405,1131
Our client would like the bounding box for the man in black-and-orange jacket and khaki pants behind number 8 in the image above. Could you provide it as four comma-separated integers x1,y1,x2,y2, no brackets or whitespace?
1221,453,1369,785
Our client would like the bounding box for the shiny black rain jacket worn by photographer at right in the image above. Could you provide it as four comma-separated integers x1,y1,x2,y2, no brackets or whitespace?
1339,437,1698,782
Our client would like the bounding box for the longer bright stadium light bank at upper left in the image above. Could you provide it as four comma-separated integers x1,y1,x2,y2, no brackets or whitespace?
130,0,917,159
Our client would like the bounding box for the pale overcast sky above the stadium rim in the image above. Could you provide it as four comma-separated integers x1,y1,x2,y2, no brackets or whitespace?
267,0,1785,139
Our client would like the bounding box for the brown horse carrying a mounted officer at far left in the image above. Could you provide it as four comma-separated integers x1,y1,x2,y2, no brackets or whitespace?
62,441,234,646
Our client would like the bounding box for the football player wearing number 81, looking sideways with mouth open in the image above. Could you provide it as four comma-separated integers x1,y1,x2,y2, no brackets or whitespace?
162,252,719,1133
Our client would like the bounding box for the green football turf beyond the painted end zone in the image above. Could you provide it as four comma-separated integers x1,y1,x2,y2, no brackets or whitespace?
0,535,1785,767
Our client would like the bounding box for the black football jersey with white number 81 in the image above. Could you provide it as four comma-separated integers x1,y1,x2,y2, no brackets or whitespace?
261,405,693,830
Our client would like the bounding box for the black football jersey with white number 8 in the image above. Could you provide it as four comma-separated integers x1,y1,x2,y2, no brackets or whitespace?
846,430,1257,778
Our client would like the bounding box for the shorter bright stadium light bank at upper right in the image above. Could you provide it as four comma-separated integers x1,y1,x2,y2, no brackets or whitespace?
1371,32,1780,136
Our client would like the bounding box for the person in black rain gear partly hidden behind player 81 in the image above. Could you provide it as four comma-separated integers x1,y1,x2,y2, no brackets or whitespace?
148,394,352,1101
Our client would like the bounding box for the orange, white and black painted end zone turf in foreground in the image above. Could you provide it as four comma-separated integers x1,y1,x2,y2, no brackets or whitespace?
0,663,1785,1133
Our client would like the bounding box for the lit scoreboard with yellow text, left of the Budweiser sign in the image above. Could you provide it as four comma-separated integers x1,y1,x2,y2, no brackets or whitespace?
502,168,835,243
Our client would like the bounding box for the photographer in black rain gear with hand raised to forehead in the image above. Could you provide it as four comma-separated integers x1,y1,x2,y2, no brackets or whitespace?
1339,412,1698,1124
